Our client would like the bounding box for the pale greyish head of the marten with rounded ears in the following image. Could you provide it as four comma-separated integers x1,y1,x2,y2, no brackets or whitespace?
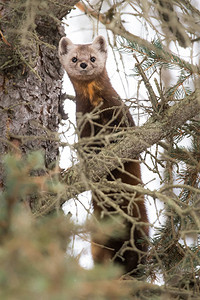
58,36,107,81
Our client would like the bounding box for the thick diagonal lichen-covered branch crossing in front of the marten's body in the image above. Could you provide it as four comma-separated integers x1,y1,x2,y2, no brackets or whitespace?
36,89,200,214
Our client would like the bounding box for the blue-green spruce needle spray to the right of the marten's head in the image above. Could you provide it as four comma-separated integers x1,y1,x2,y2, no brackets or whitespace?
119,38,199,99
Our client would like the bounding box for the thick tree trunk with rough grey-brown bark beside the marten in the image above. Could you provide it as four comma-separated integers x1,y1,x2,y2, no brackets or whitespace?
0,0,77,182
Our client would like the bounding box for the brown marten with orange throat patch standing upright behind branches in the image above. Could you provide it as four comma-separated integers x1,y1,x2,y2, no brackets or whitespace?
58,36,148,276
